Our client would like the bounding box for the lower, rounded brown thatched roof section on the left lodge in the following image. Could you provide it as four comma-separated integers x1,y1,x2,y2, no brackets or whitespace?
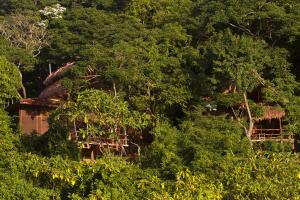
38,81,67,99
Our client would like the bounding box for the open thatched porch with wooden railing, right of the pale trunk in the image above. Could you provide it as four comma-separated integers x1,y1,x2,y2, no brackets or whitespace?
251,106,295,146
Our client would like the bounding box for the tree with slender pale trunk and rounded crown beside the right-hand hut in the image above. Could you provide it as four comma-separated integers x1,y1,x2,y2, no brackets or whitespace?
199,31,297,139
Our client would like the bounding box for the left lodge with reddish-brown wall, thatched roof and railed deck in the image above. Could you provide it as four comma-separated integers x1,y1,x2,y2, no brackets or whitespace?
19,63,129,160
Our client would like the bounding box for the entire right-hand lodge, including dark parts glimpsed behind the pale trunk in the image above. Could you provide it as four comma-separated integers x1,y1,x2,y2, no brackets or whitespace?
203,87,296,149
